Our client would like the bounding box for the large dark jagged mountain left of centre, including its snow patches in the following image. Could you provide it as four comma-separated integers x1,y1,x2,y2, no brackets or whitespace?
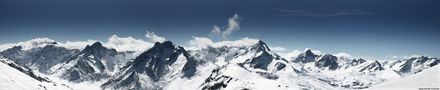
102,41,198,90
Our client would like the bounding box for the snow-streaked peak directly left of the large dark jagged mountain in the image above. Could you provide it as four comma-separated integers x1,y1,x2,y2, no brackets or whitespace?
52,42,125,82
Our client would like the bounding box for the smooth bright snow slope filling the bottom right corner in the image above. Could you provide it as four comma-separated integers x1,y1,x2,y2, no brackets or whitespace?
370,65,440,90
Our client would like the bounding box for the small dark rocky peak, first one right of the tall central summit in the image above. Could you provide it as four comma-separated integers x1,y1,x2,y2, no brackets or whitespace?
293,49,317,63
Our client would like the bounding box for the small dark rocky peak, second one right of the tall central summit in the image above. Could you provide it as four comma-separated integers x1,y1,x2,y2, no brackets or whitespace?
315,54,339,70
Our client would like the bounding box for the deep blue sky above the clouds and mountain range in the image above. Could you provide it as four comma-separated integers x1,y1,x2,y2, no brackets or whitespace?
0,0,440,57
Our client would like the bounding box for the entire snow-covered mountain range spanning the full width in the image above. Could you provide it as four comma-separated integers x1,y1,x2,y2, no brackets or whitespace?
0,40,440,90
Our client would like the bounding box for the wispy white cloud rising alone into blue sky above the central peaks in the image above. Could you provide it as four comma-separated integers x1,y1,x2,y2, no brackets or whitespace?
209,14,240,40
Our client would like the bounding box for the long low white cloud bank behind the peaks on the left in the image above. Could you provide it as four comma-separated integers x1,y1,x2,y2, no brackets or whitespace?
0,32,166,53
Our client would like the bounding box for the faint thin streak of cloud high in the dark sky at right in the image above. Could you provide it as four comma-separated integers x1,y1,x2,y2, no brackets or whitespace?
279,9,373,17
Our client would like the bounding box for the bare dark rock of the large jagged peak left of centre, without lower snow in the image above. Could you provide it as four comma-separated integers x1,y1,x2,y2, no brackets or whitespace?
102,41,198,90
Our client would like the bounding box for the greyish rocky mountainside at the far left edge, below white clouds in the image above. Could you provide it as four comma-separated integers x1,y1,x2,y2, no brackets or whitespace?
0,45,79,74
